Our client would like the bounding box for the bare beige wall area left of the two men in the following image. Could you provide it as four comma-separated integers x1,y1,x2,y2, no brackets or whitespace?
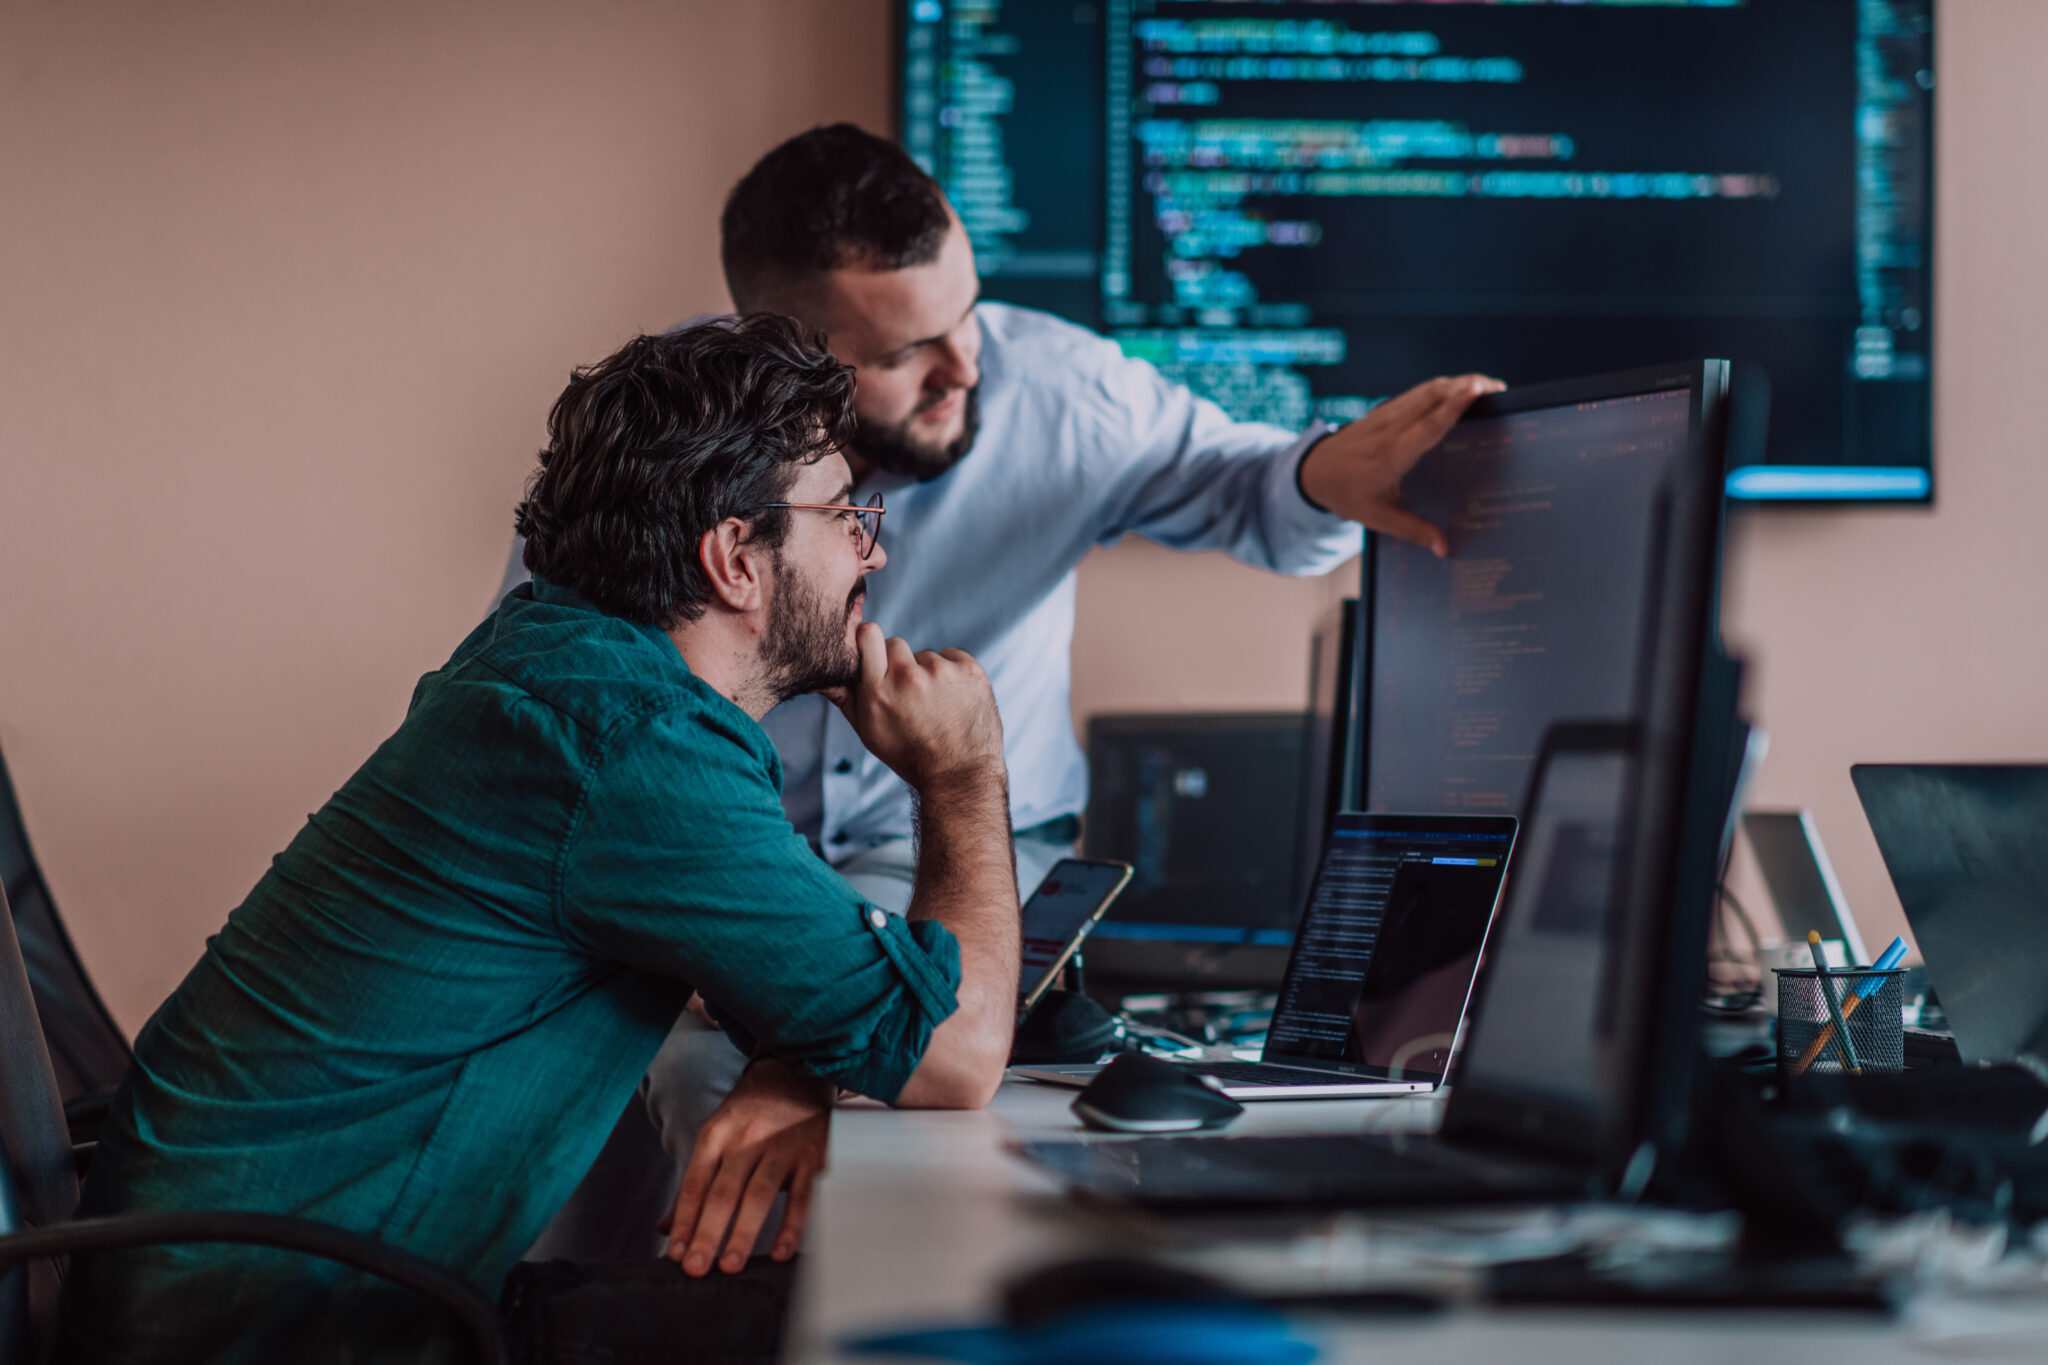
0,0,889,1027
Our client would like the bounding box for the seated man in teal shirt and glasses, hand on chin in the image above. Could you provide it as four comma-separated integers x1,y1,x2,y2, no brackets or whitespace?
66,317,1020,1365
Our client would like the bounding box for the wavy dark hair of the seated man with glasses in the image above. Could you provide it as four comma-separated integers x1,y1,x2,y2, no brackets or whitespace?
518,313,854,630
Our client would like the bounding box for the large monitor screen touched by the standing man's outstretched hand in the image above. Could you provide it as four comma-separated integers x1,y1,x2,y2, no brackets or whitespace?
1360,360,1731,814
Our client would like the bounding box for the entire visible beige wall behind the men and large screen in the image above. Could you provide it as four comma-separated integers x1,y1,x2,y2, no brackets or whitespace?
0,0,2048,1027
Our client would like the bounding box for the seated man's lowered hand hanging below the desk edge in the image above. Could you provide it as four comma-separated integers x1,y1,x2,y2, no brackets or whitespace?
662,1058,831,1275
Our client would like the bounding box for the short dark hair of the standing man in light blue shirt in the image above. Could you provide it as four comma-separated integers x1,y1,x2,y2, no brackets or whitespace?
719,123,950,309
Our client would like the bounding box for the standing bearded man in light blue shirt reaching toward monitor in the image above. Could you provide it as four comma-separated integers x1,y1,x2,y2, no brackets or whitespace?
508,123,1501,1277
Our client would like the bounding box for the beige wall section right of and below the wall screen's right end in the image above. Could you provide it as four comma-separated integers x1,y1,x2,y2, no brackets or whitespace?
1726,0,2048,952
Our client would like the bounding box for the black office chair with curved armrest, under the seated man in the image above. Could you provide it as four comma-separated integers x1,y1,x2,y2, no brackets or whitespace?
0,879,506,1365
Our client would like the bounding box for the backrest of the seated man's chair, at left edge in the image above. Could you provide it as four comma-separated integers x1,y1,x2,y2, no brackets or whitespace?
0,879,78,1361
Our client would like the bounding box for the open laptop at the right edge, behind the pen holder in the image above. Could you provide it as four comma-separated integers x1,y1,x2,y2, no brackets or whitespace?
1849,763,2048,1064
